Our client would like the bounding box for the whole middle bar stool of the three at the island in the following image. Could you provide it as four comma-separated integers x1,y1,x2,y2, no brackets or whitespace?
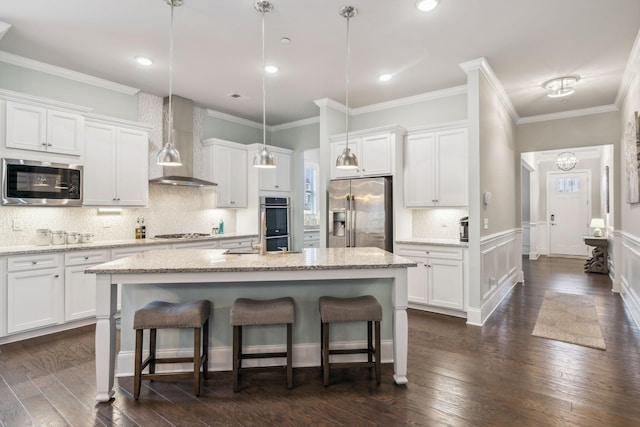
230,297,295,391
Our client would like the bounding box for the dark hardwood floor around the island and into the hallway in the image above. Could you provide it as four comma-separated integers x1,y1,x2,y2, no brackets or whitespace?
0,258,640,427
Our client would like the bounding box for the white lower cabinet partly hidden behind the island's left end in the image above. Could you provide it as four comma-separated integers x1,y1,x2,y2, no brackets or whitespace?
64,250,109,322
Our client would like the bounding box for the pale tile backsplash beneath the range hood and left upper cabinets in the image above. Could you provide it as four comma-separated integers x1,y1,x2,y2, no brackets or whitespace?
0,185,242,246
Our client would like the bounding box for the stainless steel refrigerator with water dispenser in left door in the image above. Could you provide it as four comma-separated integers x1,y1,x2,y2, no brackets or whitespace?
328,177,393,252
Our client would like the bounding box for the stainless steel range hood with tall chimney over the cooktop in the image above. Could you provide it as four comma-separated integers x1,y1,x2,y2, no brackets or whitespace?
149,95,218,187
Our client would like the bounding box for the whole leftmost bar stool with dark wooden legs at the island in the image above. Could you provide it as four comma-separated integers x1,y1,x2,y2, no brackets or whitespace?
133,300,211,400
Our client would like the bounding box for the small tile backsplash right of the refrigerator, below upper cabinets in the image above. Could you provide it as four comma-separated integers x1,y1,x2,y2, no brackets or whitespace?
412,208,469,239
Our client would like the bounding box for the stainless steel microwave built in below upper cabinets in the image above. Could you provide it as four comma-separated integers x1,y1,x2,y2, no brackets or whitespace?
2,159,82,206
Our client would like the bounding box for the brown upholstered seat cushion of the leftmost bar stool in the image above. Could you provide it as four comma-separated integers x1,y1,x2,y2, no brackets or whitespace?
133,300,211,329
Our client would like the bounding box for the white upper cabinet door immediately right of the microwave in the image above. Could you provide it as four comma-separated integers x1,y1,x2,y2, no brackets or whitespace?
83,122,116,206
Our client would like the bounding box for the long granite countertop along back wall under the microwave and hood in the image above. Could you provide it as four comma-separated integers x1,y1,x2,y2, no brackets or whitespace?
0,233,257,256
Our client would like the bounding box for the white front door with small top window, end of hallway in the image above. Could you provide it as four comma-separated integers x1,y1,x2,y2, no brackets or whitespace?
547,171,591,256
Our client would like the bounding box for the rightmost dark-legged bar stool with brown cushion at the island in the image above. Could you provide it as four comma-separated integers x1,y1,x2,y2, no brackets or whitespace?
320,295,382,386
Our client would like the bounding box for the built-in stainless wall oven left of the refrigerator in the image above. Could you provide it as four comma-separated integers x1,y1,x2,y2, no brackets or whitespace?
260,197,291,252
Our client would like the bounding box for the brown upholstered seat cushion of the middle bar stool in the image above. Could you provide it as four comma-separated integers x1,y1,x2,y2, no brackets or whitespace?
230,297,295,326
